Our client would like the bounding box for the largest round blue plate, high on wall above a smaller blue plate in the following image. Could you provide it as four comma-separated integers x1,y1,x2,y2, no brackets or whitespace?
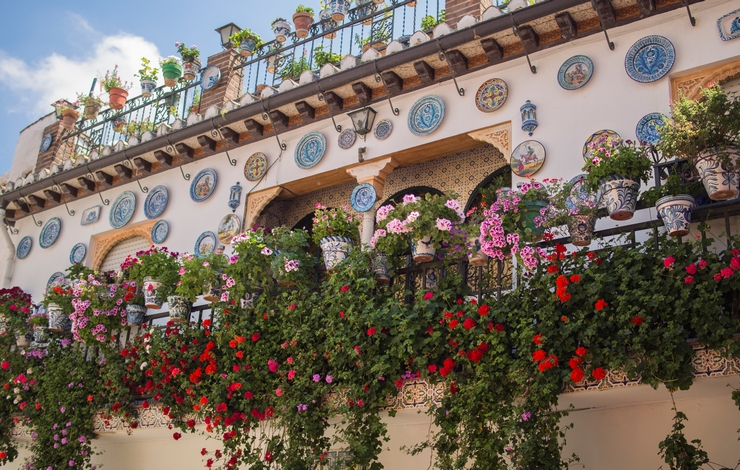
624,36,676,83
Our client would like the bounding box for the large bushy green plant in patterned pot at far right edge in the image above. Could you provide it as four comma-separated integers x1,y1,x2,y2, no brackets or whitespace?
657,84,740,201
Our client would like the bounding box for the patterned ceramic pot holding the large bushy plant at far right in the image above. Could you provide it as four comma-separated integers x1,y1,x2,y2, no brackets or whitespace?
694,148,740,201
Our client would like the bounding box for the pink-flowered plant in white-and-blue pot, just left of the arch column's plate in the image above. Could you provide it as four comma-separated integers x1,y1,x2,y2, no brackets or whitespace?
311,204,360,271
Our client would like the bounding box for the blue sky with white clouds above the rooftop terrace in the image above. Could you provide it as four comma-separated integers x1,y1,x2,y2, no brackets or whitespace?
0,0,306,175
